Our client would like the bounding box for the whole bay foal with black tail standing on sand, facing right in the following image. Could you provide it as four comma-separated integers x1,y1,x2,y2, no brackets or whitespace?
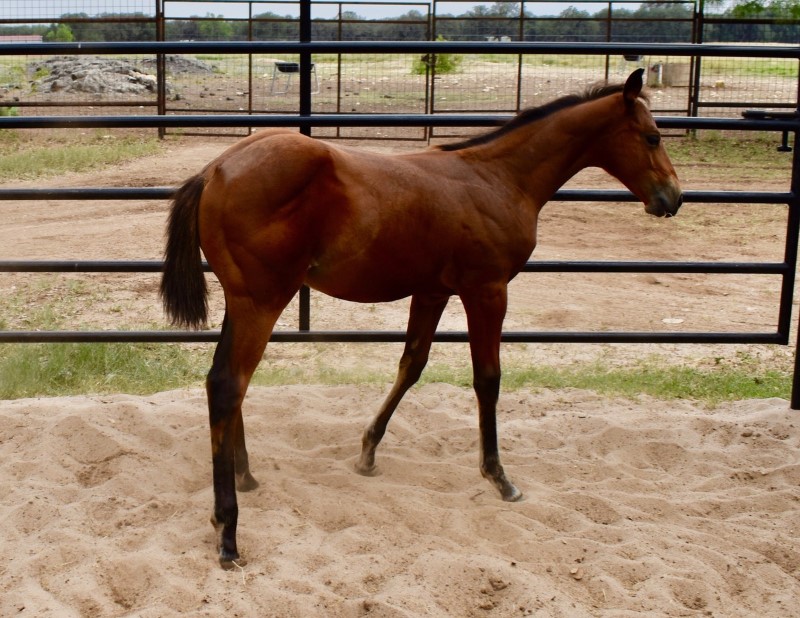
161,70,682,568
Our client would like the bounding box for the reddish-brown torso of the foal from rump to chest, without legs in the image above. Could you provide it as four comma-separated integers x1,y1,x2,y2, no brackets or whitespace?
200,131,535,302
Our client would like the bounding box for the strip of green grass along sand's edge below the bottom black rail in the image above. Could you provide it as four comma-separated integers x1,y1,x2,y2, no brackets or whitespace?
0,344,792,407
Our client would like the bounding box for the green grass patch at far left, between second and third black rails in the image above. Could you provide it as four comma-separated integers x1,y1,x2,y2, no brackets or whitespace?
0,130,162,182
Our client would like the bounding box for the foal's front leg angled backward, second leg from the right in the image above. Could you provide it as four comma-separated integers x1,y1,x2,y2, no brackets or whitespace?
356,296,449,476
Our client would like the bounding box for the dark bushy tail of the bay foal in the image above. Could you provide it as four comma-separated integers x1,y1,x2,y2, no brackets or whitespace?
160,174,208,328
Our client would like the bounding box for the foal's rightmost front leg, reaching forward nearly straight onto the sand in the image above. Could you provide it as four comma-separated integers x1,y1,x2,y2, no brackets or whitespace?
461,284,522,502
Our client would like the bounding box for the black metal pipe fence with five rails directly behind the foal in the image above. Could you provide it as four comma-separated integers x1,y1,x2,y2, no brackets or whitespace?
0,37,800,409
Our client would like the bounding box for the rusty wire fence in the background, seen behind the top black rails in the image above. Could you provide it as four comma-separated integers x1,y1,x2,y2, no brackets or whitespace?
0,0,800,130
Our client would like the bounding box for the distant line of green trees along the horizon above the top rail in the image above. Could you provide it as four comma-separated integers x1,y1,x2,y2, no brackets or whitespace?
0,0,800,44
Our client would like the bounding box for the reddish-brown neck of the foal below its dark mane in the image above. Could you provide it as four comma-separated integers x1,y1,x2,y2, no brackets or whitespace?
482,96,622,208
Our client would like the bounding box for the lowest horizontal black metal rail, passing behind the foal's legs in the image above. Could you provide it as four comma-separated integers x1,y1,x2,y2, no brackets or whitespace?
0,330,780,344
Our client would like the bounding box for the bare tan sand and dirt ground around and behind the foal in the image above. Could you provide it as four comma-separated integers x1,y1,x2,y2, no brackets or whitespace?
0,129,800,617
